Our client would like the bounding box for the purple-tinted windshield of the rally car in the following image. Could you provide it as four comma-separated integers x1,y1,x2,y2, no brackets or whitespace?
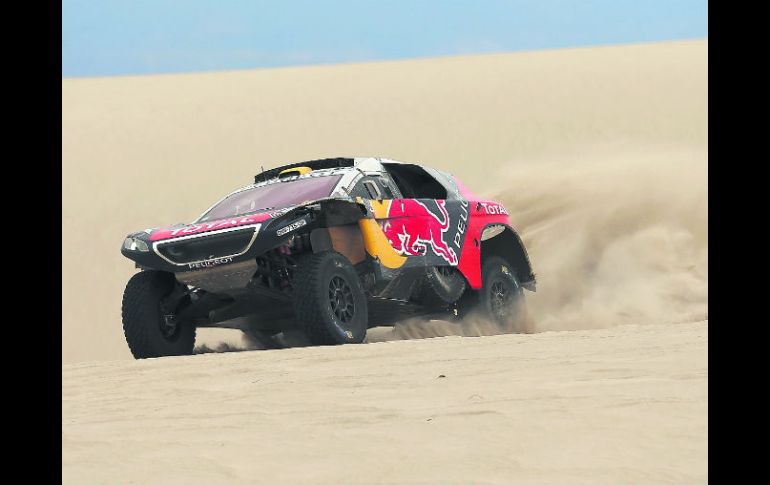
197,175,341,222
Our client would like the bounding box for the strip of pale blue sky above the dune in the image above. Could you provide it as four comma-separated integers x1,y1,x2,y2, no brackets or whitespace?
62,0,708,77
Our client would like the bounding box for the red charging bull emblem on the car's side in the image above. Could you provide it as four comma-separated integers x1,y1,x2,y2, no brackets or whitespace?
382,199,457,265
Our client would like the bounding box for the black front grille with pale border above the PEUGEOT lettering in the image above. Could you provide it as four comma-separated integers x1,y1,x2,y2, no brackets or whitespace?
157,227,254,264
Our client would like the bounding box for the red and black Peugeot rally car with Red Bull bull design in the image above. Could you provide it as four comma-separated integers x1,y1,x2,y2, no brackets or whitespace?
121,158,535,359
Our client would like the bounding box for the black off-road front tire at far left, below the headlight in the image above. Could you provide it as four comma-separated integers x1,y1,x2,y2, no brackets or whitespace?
122,270,195,359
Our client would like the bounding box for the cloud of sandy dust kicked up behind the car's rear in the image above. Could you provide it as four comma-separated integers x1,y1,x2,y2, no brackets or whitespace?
369,146,708,342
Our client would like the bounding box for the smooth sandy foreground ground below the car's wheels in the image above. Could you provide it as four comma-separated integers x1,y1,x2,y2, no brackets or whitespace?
62,322,708,484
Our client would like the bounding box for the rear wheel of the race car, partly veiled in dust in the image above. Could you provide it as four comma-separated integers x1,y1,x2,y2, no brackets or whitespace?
458,256,528,332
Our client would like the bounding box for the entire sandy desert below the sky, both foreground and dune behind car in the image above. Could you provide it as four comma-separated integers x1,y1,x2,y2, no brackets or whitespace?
62,40,708,484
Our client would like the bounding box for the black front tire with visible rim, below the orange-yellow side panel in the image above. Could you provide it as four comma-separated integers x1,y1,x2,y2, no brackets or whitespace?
293,251,369,345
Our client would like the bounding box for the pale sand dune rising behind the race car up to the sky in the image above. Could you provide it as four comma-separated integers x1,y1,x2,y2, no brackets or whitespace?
62,41,708,362
